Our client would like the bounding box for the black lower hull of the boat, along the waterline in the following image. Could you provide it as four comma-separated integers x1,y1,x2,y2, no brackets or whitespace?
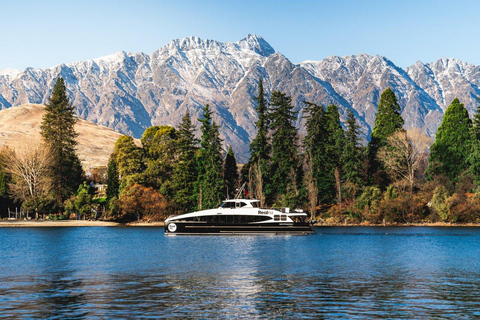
165,221,314,235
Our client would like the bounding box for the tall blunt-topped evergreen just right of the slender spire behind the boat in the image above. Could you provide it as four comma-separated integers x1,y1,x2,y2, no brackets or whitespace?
270,91,300,207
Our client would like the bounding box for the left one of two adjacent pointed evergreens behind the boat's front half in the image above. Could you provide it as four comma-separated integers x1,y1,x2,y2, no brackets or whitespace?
172,111,198,212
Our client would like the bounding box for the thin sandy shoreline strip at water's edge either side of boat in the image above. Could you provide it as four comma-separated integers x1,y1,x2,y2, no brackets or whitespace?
0,220,480,228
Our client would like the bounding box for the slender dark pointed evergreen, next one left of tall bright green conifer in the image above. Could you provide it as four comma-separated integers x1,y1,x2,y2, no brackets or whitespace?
342,111,364,185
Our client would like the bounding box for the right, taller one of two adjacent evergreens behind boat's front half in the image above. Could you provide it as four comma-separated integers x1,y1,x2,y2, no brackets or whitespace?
198,104,224,209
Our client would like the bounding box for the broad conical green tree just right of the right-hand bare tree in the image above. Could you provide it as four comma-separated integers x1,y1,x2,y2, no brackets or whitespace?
427,98,472,183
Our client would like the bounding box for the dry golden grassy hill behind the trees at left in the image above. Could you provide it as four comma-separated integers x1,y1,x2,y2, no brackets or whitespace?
0,104,131,171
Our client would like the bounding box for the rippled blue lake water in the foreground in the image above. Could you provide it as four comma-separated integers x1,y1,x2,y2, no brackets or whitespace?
0,227,480,319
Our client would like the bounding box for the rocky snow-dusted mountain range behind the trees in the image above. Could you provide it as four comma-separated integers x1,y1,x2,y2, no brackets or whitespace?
0,35,480,162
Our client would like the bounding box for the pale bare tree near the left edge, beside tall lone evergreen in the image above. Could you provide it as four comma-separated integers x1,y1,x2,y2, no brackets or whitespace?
2,140,52,216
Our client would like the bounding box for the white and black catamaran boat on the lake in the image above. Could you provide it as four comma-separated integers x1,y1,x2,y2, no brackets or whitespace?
165,199,313,235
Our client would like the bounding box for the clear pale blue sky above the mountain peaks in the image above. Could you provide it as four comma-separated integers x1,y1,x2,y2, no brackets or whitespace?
0,0,480,70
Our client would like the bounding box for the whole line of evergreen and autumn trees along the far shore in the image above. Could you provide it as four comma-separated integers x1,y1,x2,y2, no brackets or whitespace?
0,78,480,224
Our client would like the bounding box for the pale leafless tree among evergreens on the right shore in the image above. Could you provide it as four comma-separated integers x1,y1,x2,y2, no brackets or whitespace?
378,129,432,193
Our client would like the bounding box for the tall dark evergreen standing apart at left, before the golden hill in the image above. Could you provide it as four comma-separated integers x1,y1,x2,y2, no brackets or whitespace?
40,78,83,207
